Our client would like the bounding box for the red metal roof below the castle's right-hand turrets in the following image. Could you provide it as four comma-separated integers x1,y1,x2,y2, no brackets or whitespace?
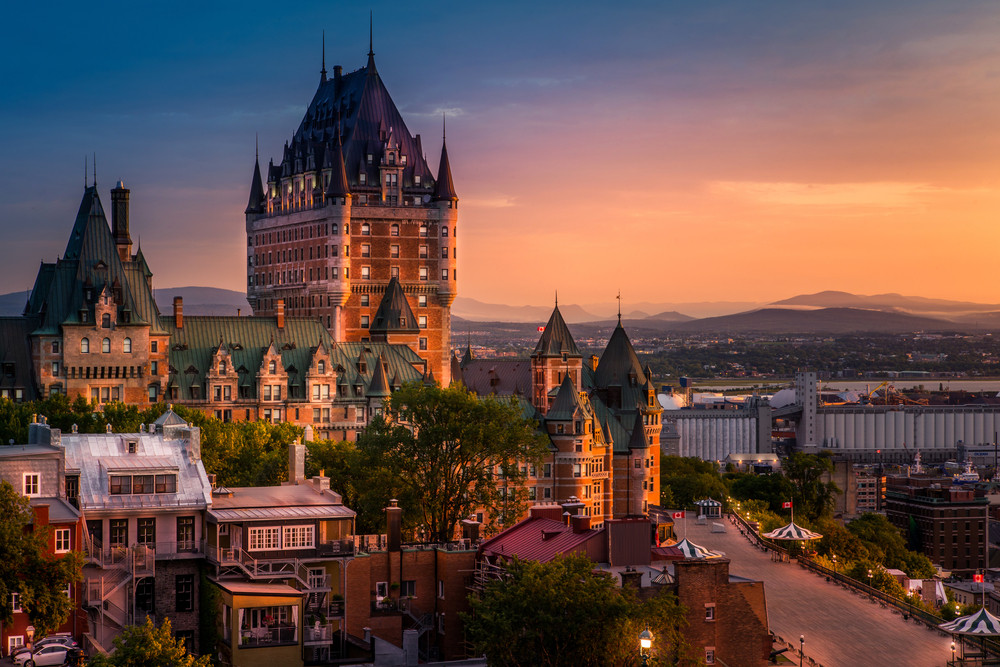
479,517,604,563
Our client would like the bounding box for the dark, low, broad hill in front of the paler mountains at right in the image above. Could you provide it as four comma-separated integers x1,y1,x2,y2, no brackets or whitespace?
668,308,956,334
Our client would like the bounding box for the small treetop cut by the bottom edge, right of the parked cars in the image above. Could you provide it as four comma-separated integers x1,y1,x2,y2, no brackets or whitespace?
88,616,212,667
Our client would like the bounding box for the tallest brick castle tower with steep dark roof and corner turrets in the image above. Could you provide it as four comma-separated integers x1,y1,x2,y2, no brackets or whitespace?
246,36,458,385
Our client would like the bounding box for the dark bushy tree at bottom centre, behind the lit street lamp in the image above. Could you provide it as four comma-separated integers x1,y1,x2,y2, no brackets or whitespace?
462,555,697,667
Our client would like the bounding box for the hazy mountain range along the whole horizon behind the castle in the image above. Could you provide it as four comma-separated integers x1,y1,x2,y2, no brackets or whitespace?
0,286,1000,334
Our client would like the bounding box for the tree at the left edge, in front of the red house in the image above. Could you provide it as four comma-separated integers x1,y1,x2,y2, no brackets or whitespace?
0,481,83,637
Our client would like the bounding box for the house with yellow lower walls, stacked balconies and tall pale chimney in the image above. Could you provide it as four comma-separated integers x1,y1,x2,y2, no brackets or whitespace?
205,443,360,667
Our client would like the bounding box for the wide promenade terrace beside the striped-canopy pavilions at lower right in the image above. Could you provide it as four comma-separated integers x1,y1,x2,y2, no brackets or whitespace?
677,520,951,667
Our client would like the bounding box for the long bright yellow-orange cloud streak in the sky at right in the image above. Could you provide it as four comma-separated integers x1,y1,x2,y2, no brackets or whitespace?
708,181,986,208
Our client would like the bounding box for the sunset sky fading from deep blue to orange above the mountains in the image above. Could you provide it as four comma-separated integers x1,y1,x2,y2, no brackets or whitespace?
0,0,1000,308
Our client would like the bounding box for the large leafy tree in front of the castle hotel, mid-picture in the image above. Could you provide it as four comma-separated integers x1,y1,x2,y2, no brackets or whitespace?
358,383,548,541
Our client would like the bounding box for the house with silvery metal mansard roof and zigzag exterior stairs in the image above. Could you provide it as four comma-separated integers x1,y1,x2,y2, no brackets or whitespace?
62,410,212,652
